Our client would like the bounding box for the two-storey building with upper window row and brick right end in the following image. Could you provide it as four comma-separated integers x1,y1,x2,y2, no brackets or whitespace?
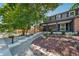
41,4,79,32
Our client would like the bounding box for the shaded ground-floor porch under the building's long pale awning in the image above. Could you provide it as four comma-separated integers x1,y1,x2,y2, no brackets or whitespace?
42,20,74,32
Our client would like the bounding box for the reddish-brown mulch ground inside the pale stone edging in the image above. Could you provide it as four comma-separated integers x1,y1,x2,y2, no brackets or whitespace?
32,36,79,56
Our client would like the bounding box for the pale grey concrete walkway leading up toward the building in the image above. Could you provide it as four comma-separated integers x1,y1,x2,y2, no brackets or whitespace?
0,32,43,56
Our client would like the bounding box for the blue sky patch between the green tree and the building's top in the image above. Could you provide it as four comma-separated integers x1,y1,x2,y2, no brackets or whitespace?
46,3,74,17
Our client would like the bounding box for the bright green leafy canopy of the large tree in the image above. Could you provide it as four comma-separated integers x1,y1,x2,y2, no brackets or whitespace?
0,3,58,34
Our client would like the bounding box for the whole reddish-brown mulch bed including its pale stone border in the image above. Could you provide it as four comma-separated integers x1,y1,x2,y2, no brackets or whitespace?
32,36,79,56
